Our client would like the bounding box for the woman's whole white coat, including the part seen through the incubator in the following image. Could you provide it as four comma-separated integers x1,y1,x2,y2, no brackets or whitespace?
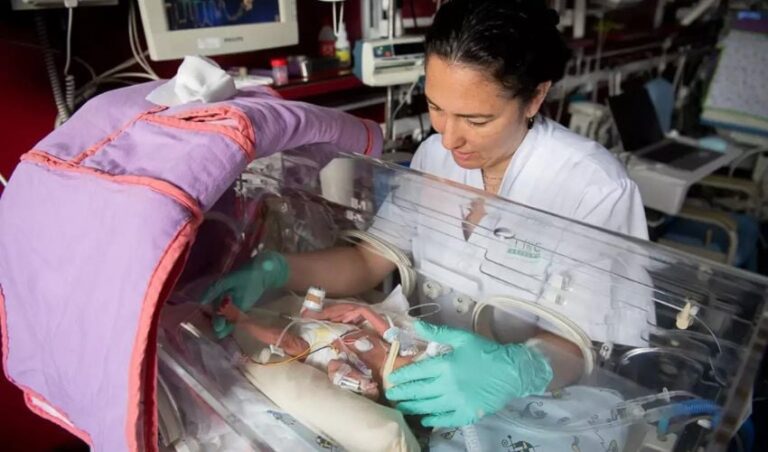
372,119,655,345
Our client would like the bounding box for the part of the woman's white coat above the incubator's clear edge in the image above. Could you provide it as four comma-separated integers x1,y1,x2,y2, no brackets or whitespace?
411,115,648,239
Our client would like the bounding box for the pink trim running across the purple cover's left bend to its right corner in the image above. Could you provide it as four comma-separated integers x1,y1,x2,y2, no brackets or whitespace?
21,149,203,218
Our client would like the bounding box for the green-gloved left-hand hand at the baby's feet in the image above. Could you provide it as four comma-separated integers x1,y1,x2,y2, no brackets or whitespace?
203,251,289,339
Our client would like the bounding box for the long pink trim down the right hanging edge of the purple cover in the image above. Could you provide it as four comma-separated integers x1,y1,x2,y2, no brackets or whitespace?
125,218,201,452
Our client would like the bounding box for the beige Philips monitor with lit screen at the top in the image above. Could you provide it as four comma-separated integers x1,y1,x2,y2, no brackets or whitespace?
139,0,299,61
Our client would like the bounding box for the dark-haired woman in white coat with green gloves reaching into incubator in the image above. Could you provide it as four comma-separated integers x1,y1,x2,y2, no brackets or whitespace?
205,0,647,427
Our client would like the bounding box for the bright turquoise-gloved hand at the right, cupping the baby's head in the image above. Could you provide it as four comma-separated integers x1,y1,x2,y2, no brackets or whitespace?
386,321,552,427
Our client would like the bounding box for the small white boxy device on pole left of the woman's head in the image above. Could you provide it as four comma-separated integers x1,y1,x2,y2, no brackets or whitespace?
354,36,425,86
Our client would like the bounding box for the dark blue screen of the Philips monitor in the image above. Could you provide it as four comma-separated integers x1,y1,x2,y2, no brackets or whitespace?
165,0,280,31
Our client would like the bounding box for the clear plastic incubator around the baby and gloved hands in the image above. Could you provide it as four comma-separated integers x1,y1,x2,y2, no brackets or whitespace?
158,149,768,452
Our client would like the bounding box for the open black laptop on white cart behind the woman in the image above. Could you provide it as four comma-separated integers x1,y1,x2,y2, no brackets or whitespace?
608,87,723,171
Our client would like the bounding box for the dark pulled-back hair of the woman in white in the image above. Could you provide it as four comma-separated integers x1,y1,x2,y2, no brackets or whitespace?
426,0,571,103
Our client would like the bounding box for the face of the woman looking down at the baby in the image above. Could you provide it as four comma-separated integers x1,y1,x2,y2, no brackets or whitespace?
425,56,549,169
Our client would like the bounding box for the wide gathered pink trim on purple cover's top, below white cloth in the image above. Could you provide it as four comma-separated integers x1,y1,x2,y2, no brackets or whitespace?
142,105,256,162
